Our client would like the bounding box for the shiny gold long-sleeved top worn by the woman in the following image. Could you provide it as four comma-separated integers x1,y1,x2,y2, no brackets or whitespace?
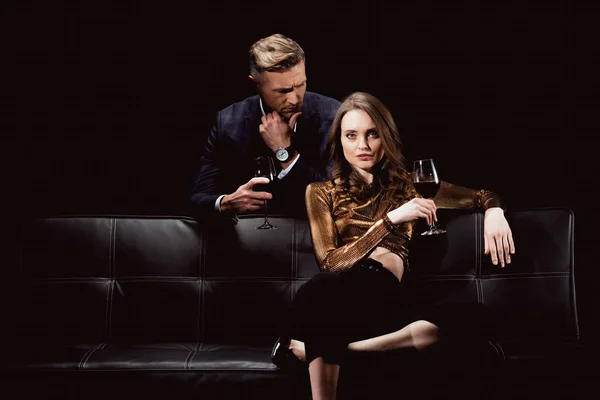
306,181,502,272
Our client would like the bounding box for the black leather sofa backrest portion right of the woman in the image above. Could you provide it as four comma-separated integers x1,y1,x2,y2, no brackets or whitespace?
410,208,579,341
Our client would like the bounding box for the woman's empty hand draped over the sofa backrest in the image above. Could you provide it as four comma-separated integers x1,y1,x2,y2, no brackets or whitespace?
483,207,515,268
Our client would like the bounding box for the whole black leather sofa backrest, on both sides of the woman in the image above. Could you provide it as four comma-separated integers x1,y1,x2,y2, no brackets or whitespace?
12,209,578,344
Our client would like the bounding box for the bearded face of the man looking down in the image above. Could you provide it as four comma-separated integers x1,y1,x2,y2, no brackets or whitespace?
256,61,306,120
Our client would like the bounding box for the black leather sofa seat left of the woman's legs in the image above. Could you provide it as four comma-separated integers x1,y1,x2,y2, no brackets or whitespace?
0,343,310,400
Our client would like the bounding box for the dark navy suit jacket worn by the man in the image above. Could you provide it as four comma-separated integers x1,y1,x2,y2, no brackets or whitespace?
191,92,340,220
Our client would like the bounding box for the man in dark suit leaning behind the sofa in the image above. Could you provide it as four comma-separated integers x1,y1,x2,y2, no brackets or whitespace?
191,34,340,220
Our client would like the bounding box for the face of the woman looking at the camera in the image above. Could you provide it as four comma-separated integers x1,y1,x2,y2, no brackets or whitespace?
341,110,384,174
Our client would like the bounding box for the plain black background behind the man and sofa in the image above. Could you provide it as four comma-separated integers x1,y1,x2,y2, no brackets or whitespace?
0,0,600,344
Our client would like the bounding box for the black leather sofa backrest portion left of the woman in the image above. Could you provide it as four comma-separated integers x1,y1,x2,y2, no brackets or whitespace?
15,216,318,343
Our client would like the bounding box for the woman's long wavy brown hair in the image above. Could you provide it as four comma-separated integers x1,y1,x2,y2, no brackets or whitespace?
327,92,415,203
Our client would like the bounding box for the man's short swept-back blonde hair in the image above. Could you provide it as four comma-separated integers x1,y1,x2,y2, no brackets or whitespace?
249,33,306,80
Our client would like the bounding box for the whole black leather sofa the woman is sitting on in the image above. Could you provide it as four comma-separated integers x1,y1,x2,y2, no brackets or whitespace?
1,208,588,399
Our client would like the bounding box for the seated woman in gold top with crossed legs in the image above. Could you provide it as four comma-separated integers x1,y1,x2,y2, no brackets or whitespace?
274,92,515,400
